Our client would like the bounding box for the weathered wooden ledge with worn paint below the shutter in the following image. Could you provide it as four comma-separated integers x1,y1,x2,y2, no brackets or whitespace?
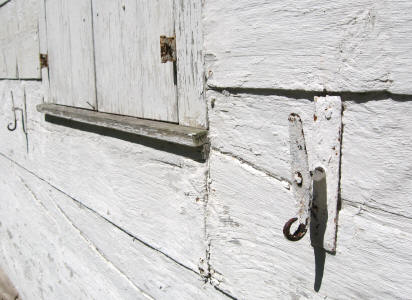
37,103,207,147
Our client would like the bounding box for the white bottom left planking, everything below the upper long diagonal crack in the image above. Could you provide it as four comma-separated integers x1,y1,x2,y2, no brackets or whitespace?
0,157,223,299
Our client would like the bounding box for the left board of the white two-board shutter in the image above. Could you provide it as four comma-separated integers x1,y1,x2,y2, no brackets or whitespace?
45,0,96,109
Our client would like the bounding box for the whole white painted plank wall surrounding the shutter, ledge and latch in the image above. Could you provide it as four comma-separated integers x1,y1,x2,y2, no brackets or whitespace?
0,0,412,299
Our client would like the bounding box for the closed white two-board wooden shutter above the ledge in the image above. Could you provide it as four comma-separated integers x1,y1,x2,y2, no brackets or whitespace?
46,0,179,122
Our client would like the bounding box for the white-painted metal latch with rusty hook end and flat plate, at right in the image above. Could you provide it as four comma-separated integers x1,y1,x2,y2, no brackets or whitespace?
283,96,342,253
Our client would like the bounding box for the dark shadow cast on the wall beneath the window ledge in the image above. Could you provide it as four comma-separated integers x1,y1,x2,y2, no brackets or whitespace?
45,114,205,163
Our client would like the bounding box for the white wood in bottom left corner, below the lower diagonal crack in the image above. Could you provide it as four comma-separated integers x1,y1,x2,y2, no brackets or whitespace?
0,156,152,299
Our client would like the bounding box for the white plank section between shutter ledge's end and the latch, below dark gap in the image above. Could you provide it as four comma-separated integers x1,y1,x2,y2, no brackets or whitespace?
207,91,314,180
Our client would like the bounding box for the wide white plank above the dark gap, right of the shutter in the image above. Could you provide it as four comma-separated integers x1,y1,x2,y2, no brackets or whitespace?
204,0,412,94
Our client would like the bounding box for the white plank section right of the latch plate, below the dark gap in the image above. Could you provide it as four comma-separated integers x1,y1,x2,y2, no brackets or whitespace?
341,98,412,217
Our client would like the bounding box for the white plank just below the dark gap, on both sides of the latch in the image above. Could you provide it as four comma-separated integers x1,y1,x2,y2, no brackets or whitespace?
208,91,412,218
